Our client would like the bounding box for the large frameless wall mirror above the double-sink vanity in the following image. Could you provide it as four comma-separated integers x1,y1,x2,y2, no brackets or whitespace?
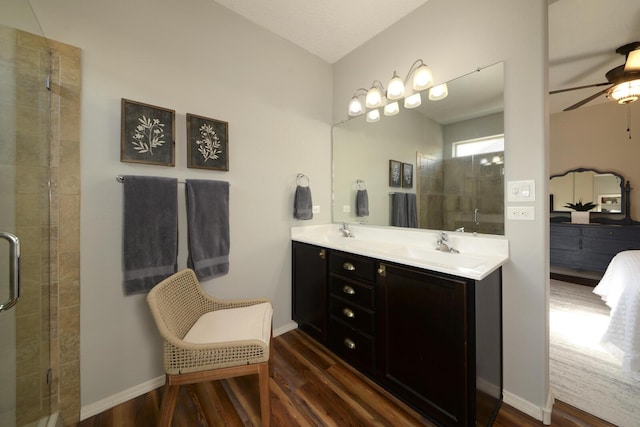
332,63,505,234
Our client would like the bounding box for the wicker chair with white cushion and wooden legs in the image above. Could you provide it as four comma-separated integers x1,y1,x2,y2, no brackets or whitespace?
147,269,273,426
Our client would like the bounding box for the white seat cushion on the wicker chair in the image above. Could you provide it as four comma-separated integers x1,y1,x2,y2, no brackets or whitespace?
183,302,273,345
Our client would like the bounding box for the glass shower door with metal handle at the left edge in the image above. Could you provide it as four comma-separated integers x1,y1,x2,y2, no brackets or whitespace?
0,15,51,426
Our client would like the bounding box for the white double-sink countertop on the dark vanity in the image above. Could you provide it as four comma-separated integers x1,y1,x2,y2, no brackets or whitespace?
291,224,509,280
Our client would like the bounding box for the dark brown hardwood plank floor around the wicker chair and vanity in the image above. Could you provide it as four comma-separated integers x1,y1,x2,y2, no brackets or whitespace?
76,330,612,427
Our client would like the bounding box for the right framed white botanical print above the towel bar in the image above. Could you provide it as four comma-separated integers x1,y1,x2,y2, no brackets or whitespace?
187,114,229,171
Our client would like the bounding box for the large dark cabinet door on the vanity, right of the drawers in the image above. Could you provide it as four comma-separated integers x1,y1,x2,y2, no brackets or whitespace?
379,263,475,425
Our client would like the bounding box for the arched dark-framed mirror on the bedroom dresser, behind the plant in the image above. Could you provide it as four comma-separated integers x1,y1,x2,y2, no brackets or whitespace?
549,168,628,215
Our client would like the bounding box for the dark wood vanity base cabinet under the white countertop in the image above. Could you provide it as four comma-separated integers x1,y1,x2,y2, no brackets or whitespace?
293,241,502,426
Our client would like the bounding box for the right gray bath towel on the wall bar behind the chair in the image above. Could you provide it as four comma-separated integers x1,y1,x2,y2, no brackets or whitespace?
185,179,230,280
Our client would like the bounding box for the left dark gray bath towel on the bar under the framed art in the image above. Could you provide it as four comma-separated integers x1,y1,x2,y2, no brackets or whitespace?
123,175,178,295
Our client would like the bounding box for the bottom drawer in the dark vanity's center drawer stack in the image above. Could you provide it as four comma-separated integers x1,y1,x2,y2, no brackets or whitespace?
329,318,374,372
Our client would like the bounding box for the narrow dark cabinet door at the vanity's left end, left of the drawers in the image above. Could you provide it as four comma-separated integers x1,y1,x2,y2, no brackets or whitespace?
291,242,328,342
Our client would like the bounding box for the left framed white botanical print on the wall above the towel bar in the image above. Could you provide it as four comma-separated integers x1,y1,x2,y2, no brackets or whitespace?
120,98,176,166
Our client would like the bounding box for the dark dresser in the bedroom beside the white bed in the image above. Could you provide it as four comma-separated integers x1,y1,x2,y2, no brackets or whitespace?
549,223,640,272
